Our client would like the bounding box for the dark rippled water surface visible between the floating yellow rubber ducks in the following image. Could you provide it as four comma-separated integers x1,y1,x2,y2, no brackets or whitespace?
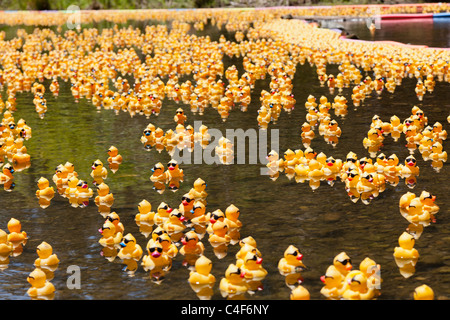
0,18,450,300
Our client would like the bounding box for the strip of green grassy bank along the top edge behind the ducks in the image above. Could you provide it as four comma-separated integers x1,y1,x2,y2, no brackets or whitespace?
0,0,436,10
